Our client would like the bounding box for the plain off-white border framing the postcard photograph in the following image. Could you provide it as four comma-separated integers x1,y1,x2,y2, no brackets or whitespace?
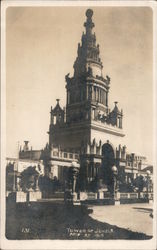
1,0,157,250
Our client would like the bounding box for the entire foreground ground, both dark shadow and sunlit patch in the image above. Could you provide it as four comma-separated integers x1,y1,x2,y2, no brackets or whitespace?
6,202,153,240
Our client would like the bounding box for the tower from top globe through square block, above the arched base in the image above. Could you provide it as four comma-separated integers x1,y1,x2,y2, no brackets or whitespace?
49,9,124,152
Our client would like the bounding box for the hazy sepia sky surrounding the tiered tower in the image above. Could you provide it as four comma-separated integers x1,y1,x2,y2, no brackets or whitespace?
6,7,153,163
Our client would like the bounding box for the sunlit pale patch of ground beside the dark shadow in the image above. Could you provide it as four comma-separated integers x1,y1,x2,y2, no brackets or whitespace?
90,203,153,236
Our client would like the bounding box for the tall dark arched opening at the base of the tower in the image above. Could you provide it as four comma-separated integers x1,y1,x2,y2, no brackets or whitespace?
102,143,115,192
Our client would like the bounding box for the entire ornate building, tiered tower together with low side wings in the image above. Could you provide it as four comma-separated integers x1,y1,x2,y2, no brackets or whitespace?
6,9,152,197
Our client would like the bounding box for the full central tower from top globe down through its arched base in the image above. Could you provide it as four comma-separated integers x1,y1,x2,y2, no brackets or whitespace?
48,9,127,192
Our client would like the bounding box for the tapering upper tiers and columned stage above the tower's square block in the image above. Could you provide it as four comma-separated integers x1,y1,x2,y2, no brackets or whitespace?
66,9,110,123
